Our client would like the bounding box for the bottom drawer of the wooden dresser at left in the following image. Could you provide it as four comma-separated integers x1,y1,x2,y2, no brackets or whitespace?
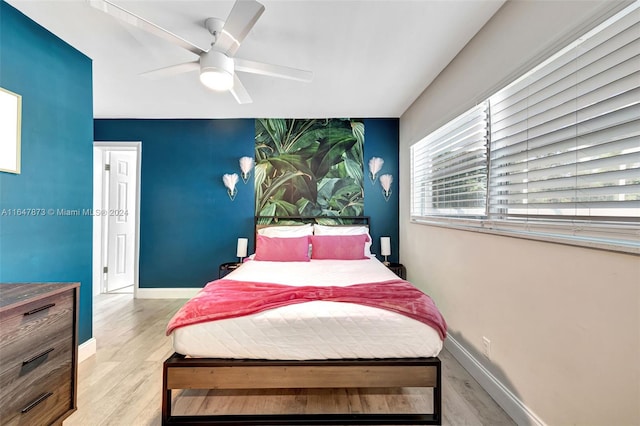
0,364,74,426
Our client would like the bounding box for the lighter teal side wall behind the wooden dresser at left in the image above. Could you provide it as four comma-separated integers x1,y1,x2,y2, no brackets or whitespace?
0,1,93,342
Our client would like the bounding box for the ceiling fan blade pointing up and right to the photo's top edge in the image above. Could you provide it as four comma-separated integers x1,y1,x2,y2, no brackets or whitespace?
215,0,264,56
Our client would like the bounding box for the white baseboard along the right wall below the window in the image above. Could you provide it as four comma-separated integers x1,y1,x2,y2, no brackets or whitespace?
444,335,546,426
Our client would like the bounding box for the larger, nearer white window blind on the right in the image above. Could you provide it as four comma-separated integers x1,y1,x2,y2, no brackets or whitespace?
489,8,640,220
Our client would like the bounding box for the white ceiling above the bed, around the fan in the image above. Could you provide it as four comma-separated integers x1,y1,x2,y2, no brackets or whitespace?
8,0,504,118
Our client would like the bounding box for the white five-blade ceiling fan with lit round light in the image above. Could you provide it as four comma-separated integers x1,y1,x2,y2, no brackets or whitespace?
88,0,313,104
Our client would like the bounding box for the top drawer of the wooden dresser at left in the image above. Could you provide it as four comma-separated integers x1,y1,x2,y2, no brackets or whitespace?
0,291,74,372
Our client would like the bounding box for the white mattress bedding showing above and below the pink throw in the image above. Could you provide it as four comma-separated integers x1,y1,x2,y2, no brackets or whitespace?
172,259,442,360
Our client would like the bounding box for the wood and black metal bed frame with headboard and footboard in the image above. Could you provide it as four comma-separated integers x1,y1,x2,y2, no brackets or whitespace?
162,216,442,425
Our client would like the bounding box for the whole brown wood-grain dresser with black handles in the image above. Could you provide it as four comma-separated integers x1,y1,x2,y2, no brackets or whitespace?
0,283,80,426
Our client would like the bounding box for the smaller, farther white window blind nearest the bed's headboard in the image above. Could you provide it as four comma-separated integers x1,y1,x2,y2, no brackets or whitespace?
411,102,488,217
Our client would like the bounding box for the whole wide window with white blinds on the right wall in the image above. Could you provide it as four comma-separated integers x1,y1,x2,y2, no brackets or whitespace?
411,3,640,253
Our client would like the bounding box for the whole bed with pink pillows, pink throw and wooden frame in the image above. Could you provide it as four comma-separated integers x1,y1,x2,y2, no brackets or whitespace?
162,217,446,425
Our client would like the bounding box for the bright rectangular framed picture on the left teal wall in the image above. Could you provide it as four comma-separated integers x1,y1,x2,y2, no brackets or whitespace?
0,87,22,174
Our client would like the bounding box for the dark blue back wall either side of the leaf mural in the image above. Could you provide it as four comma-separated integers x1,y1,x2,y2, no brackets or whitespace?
94,118,398,288
